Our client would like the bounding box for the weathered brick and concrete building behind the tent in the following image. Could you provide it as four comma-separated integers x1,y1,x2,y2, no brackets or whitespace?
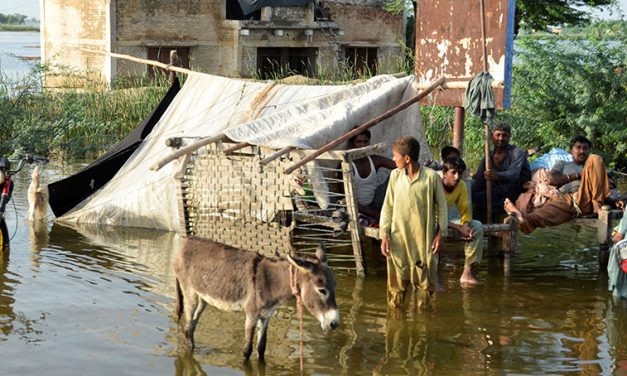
40,0,405,82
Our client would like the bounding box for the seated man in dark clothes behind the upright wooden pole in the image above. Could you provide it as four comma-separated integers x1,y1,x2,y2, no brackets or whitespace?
472,123,531,220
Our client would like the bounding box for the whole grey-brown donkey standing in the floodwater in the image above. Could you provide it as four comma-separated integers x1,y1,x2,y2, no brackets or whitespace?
174,237,340,362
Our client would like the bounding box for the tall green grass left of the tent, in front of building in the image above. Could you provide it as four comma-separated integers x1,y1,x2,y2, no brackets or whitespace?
0,66,169,159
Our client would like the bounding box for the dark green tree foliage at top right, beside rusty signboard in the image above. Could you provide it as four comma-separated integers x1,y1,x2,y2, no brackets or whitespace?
514,0,617,34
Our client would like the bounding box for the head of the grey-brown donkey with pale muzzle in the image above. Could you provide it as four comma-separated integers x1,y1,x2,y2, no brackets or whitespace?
287,246,340,331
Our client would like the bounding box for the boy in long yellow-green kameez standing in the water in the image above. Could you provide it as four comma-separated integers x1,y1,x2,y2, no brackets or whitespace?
379,137,448,307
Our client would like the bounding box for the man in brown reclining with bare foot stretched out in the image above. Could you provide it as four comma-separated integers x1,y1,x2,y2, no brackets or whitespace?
505,136,610,234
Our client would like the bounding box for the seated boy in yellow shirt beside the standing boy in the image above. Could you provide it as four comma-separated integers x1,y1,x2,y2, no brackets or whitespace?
442,157,483,284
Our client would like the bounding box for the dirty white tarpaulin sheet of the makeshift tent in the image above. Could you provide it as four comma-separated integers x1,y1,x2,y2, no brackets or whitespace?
58,73,430,231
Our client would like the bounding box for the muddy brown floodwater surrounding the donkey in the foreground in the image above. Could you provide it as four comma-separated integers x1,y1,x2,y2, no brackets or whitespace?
0,167,627,375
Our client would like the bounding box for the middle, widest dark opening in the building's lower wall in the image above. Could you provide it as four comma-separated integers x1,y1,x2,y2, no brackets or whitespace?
257,47,318,80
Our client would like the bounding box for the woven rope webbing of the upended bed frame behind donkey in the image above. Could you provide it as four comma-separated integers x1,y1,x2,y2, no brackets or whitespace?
180,145,293,255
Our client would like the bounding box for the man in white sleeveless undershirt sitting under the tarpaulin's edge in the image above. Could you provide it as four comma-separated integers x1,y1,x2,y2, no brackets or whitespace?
348,129,396,225
